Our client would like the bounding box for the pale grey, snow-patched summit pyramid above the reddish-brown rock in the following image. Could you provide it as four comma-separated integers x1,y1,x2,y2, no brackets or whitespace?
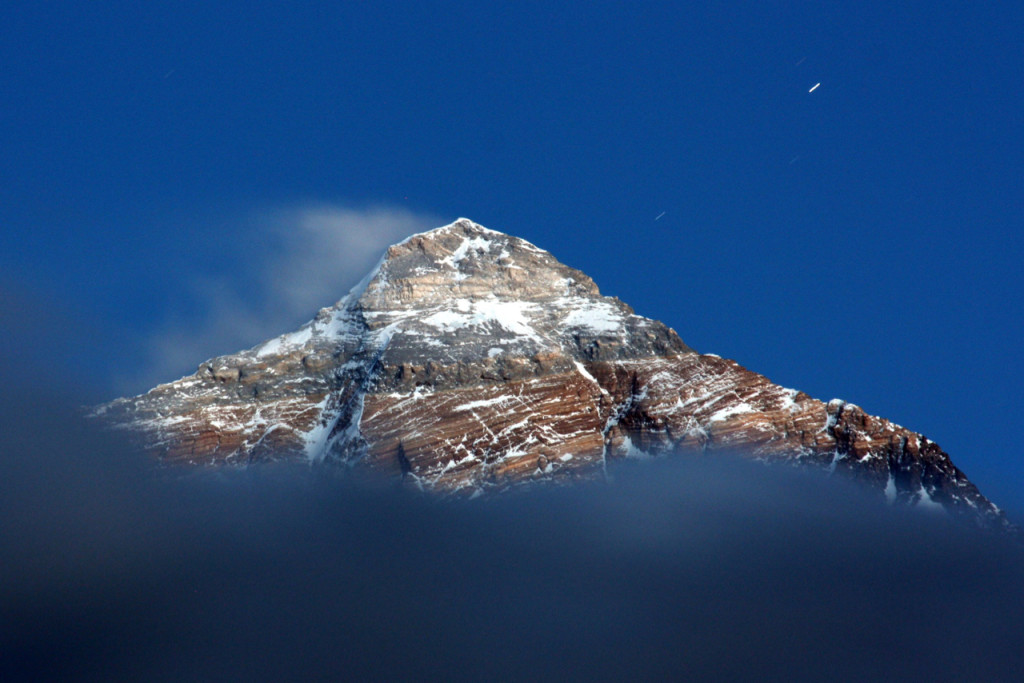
254,218,689,362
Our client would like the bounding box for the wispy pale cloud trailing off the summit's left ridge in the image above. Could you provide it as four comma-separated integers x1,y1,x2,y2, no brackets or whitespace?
121,204,444,393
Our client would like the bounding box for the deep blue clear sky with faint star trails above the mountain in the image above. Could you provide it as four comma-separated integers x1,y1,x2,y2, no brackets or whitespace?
0,1,1024,510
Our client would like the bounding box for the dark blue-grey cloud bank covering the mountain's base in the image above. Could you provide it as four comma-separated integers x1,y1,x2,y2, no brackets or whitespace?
0,392,1024,681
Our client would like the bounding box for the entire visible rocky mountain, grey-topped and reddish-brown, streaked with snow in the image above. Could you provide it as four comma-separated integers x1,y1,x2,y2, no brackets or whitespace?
94,219,1009,527
